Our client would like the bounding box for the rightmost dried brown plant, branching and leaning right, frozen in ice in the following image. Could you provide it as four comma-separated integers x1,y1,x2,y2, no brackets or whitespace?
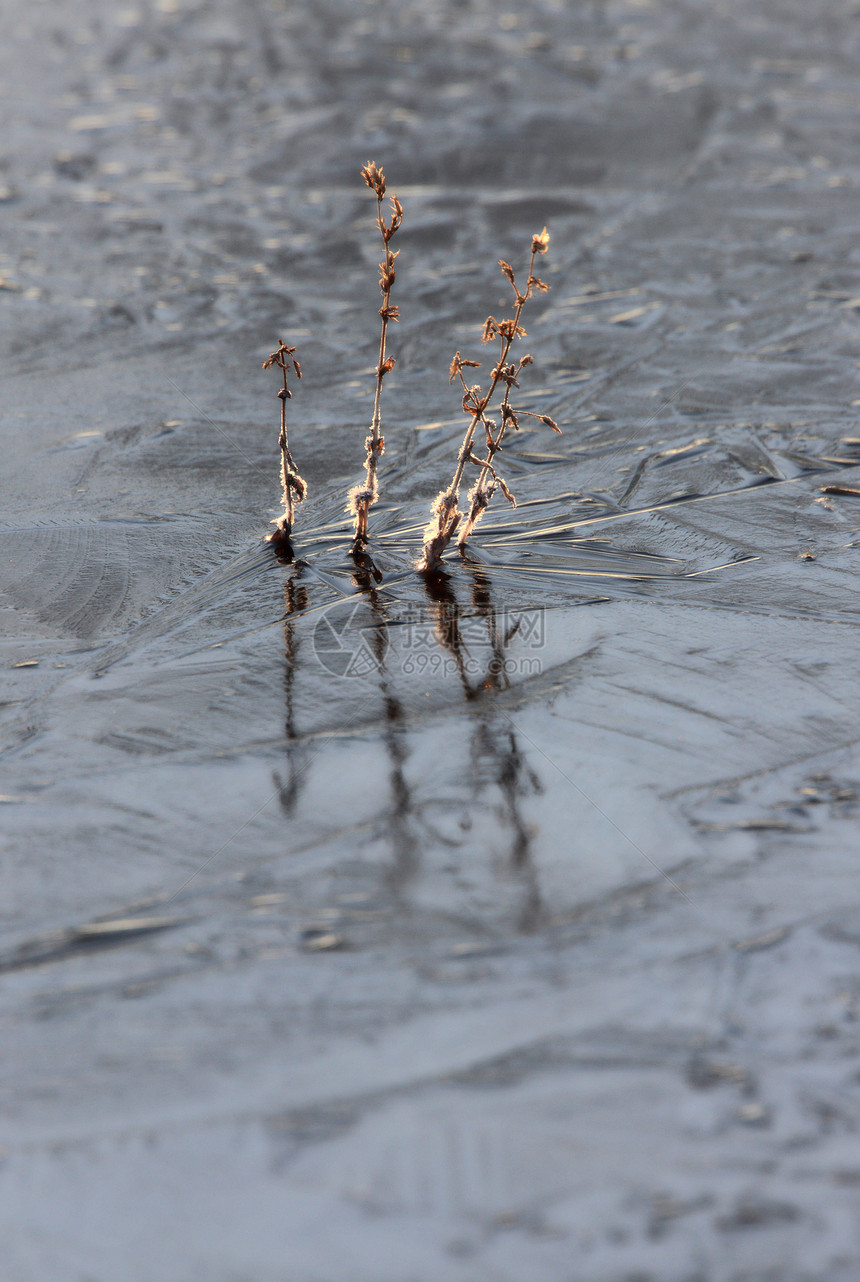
420,227,559,569
